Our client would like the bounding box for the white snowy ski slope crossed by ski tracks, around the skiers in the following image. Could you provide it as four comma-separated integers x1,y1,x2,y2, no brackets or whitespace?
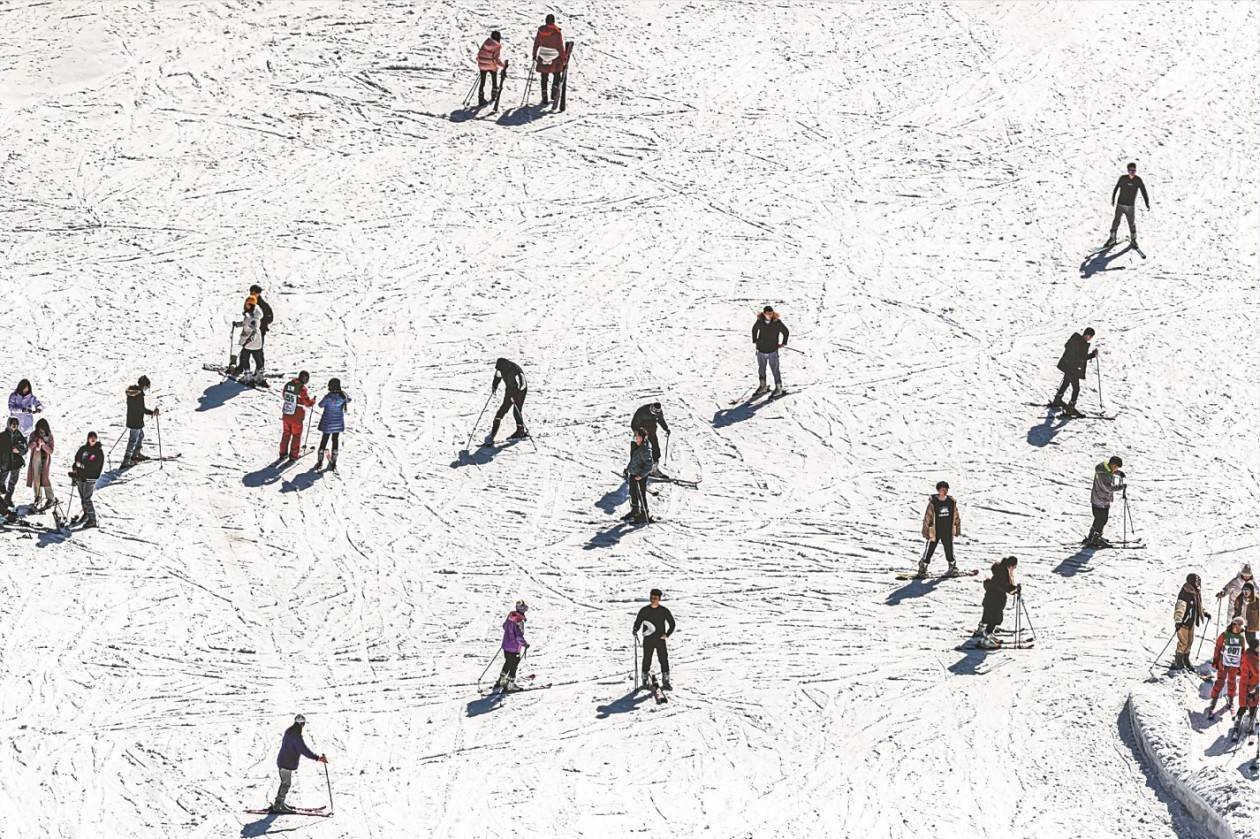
0,0,1260,839
